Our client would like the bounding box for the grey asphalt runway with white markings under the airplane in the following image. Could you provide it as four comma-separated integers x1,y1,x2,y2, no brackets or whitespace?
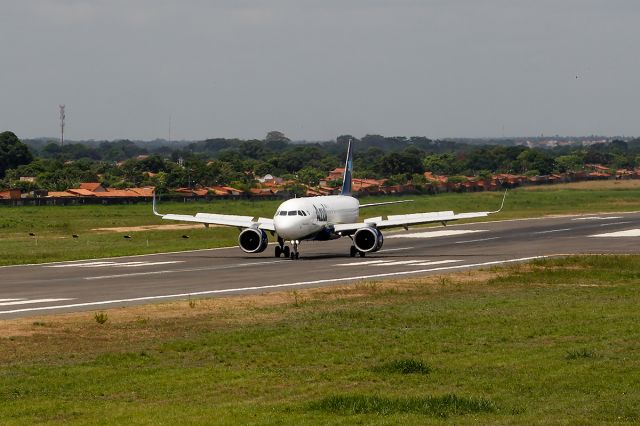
0,212,640,319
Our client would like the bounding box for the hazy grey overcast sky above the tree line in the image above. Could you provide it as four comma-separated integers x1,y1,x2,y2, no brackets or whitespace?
0,0,640,140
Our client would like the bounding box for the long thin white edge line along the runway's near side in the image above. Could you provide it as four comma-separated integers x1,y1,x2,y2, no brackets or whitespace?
0,256,550,314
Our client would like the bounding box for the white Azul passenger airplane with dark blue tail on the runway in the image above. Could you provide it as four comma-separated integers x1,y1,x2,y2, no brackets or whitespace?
153,140,507,260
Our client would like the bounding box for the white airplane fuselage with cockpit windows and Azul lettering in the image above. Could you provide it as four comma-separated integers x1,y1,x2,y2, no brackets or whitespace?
273,195,360,241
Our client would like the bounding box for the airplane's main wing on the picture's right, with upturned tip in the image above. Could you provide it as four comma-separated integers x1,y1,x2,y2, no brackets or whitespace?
333,191,507,235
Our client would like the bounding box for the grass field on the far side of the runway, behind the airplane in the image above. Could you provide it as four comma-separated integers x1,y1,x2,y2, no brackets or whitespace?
0,181,640,265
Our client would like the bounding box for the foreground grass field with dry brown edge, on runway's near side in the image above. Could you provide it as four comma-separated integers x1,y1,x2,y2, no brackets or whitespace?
0,256,640,425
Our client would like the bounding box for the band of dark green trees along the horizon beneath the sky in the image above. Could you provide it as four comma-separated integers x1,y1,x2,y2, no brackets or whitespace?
0,131,640,191
